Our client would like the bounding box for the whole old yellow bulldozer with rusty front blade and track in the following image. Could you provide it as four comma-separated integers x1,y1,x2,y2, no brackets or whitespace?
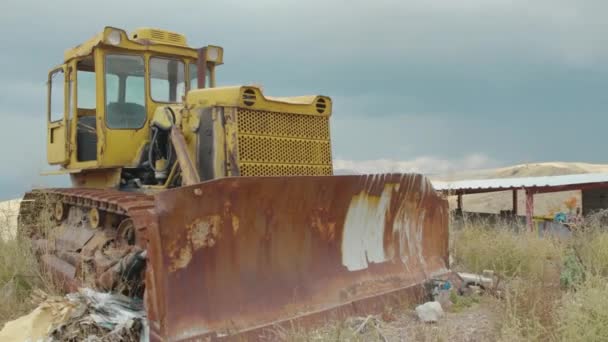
19,27,448,341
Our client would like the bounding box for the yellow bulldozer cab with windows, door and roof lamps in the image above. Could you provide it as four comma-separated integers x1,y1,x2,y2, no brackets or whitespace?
47,27,222,173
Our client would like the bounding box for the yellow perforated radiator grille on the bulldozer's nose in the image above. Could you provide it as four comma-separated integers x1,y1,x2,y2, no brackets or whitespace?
237,108,332,176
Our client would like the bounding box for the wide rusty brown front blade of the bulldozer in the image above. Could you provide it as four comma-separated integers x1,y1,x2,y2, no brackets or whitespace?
146,174,448,341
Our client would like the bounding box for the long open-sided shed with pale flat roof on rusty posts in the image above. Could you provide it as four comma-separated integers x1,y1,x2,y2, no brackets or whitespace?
433,173,608,228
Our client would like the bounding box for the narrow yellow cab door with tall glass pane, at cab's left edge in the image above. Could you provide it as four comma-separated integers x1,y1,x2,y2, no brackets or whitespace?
46,65,70,164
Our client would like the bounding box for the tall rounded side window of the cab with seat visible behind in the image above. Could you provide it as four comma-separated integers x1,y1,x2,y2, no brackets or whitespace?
105,55,146,129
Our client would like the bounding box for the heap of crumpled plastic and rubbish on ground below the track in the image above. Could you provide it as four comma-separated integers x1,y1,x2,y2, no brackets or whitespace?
0,288,148,342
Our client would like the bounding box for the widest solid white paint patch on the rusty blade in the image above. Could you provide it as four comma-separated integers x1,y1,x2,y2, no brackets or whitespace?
342,185,394,271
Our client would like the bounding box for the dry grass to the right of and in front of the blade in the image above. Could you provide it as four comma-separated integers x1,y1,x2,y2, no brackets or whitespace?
278,215,608,342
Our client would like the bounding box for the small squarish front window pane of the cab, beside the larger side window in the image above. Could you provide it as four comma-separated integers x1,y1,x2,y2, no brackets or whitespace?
150,57,186,103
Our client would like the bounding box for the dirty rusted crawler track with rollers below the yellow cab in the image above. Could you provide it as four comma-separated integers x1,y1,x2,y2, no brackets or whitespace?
18,189,155,292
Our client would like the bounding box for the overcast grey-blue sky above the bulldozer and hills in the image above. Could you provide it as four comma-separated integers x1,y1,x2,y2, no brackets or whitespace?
0,0,608,199
